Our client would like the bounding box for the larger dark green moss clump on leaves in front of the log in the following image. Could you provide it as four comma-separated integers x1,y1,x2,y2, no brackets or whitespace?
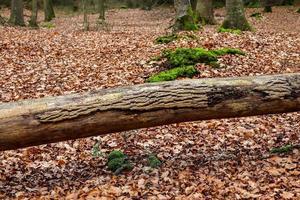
107,150,133,174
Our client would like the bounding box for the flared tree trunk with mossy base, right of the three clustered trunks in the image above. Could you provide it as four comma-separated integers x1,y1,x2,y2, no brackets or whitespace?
222,0,251,31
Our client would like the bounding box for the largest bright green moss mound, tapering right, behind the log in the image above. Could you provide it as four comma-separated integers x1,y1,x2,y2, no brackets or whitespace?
163,48,245,68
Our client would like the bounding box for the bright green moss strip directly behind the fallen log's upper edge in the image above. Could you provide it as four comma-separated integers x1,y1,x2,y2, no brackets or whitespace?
147,66,198,83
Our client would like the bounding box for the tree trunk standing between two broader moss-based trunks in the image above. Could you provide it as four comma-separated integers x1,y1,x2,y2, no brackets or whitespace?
196,0,216,24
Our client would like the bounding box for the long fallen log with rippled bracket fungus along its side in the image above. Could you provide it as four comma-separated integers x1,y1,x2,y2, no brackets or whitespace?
0,73,300,150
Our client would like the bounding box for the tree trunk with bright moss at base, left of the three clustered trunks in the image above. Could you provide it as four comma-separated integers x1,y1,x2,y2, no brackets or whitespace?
173,0,199,32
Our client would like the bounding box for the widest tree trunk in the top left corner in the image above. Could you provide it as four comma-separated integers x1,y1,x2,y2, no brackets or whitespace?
8,0,25,26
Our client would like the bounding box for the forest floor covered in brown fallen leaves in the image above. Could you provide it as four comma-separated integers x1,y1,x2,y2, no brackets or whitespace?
0,7,300,199
